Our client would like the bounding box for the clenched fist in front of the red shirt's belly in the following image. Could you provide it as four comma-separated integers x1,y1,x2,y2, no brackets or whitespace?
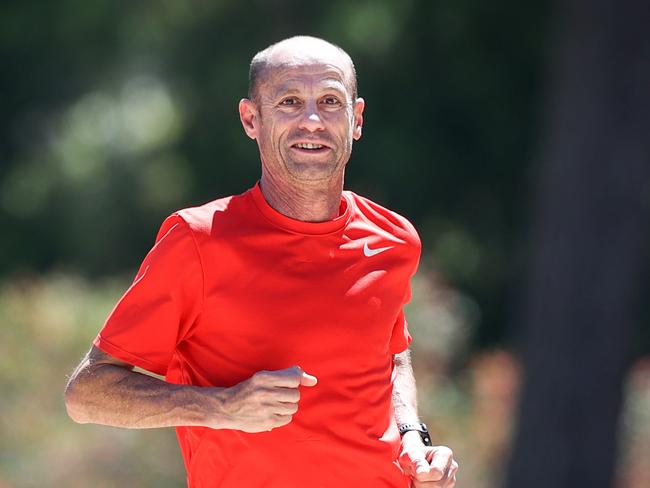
220,366,317,432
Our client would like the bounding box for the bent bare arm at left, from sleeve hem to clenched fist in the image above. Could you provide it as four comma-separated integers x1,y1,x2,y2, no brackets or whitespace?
65,346,316,432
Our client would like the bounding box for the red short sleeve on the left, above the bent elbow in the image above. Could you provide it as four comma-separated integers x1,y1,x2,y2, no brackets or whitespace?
93,215,203,375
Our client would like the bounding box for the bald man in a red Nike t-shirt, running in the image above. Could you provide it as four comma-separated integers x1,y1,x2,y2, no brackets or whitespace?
65,37,458,488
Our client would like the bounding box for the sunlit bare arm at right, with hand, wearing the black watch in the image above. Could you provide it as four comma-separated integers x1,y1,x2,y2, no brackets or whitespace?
393,349,458,488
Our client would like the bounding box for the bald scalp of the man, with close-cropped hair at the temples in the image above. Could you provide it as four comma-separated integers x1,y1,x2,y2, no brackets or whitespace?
248,36,357,104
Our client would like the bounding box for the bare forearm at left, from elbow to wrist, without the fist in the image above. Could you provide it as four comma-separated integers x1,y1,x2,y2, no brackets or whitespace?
65,350,226,428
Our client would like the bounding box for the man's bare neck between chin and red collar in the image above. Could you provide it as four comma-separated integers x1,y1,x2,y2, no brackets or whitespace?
260,171,343,222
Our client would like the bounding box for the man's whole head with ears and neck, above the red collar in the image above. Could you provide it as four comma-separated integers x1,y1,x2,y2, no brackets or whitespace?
239,36,365,222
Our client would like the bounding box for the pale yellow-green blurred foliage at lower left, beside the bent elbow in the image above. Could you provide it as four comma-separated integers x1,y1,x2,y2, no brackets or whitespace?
0,274,185,488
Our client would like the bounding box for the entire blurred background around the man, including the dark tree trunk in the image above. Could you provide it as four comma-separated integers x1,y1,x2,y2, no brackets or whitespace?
0,0,650,488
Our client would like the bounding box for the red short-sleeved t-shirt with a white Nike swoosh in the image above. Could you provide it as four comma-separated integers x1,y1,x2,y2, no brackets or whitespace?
94,185,420,488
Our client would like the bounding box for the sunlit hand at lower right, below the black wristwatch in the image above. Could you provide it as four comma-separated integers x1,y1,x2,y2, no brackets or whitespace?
399,432,458,488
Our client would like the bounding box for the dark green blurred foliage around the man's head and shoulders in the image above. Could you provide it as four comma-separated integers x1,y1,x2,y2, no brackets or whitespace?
0,0,547,345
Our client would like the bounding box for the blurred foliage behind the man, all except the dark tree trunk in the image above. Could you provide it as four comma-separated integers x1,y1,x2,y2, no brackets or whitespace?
0,0,650,488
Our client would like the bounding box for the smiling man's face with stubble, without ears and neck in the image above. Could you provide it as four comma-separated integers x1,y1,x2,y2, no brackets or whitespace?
254,45,354,182
